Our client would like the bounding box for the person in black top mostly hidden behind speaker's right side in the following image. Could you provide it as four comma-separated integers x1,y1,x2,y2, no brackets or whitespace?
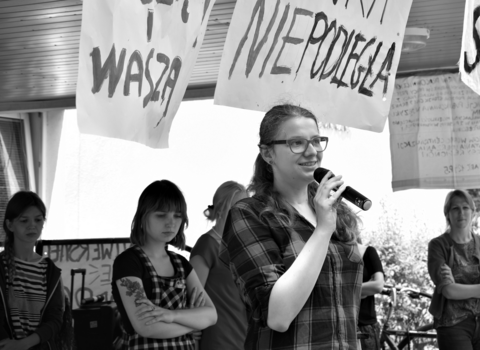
358,239,385,350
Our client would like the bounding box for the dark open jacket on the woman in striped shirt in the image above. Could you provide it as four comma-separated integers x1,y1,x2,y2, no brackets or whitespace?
0,252,64,350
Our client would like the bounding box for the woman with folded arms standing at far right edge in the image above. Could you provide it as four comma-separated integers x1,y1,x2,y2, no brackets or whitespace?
428,190,480,350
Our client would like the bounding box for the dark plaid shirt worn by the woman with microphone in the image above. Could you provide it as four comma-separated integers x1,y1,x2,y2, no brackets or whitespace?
220,196,363,350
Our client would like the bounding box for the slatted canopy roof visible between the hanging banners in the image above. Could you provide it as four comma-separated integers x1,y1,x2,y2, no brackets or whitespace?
0,0,465,111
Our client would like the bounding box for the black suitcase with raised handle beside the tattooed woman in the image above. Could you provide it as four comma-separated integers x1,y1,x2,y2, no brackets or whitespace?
70,269,121,350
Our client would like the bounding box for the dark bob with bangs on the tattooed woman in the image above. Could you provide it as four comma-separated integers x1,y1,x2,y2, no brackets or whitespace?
130,180,188,250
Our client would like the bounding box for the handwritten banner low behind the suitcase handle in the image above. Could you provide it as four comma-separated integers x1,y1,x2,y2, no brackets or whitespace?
43,243,130,308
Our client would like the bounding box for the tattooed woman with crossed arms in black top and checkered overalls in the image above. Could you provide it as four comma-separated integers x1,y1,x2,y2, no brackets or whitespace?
112,180,217,350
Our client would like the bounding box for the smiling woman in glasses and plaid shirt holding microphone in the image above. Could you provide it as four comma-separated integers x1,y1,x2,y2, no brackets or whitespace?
220,105,363,350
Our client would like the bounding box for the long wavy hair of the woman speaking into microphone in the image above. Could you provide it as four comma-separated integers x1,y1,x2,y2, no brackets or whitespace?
248,104,359,242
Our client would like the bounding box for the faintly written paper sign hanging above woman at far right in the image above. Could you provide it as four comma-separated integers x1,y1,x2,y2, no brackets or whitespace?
389,74,480,191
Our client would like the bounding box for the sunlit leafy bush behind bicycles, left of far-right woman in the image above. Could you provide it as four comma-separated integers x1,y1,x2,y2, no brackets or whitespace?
361,202,442,349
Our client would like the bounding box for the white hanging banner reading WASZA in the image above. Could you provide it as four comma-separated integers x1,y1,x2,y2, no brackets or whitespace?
77,0,214,148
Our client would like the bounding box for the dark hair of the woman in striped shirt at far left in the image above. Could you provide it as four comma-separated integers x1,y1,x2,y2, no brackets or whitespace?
3,191,47,281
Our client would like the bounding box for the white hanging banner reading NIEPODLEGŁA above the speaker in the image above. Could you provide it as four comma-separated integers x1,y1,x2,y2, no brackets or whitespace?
215,0,412,132
